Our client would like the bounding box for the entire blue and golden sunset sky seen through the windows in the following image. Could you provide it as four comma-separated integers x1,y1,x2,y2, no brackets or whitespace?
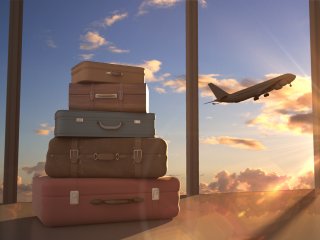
0,0,313,201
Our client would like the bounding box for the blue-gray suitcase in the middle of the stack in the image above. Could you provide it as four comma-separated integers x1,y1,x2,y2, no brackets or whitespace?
54,110,155,138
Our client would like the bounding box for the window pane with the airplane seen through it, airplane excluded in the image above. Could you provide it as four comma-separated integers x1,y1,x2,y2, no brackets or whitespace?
199,0,314,193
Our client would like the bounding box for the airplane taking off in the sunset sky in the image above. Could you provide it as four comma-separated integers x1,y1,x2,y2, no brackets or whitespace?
205,73,296,105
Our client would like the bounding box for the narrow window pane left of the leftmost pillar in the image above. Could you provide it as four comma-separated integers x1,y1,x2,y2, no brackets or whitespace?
0,1,9,203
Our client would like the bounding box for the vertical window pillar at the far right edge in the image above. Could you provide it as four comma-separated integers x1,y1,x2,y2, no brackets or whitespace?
309,0,320,188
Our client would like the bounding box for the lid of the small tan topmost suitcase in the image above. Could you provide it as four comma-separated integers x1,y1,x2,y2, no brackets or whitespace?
71,61,144,75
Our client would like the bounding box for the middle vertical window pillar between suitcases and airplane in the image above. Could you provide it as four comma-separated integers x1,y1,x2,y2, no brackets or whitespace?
186,0,199,196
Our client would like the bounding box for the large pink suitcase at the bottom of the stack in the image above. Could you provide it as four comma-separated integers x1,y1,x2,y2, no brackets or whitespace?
32,176,180,226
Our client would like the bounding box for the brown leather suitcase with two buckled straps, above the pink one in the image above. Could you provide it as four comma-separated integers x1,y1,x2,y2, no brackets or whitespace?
45,137,167,178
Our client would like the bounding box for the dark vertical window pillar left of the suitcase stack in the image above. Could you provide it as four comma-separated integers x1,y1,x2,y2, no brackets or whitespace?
3,0,23,203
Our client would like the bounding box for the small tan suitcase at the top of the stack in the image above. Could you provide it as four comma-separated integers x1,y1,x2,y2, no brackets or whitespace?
71,61,144,83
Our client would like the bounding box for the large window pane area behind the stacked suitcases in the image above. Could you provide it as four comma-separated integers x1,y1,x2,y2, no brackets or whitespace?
18,0,185,201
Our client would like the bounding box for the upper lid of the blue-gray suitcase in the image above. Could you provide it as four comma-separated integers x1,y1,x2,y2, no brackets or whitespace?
55,110,155,120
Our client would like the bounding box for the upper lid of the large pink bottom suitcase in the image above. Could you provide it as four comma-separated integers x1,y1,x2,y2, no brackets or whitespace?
33,176,180,198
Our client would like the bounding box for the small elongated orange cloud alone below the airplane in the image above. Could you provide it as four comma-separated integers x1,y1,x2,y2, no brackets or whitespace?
200,136,266,150
